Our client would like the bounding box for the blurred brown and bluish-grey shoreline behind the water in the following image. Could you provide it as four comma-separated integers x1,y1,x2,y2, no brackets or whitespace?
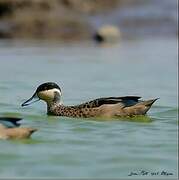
0,0,178,41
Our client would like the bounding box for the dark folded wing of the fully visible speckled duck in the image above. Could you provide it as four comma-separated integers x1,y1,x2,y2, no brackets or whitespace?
76,96,141,108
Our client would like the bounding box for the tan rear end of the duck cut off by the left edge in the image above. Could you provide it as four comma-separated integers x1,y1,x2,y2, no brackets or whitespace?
0,117,37,140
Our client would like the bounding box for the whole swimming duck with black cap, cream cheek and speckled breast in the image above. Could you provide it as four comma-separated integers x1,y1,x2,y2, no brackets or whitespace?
22,82,158,118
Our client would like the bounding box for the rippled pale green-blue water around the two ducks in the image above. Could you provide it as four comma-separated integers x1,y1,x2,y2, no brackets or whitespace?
0,38,178,178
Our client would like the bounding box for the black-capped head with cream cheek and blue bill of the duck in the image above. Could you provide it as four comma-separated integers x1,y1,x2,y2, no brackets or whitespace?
22,82,62,106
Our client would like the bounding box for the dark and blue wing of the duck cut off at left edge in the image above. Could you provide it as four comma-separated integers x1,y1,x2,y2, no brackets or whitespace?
0,117,22,128
